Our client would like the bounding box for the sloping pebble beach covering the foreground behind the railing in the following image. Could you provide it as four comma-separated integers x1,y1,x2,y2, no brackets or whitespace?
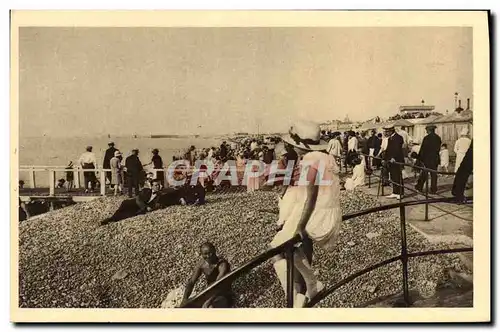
19,187,466,308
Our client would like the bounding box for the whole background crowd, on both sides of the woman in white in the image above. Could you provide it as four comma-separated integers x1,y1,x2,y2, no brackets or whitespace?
59,124,472,210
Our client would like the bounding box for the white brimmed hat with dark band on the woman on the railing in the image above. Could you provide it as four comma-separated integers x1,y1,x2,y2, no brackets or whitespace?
283,121,328,151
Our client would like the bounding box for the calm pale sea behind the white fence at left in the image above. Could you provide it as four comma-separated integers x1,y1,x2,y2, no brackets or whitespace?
19,136,225,187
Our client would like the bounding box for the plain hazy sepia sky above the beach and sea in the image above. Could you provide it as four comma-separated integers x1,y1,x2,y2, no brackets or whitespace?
19,27,474,137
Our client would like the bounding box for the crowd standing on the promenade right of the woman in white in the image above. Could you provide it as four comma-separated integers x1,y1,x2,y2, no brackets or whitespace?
322,124,471,199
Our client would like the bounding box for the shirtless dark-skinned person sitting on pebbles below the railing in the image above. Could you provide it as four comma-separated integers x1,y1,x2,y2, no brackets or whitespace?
181,242,233,308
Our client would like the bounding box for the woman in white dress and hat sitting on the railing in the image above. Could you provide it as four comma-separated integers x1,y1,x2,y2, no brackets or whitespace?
270,121,342,307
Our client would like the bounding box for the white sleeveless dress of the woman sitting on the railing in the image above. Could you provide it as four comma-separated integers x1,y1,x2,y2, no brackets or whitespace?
271,151,342,249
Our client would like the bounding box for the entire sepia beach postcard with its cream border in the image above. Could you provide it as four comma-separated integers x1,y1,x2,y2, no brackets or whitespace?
11,11,491,322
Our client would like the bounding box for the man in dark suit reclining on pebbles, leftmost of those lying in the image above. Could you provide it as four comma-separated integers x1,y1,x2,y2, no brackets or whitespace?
101,179,162,225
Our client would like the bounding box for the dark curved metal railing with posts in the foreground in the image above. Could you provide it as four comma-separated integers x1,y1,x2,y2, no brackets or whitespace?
182,192,473,308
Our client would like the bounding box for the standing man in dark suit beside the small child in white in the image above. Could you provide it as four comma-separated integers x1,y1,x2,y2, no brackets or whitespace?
415,125,441,194
